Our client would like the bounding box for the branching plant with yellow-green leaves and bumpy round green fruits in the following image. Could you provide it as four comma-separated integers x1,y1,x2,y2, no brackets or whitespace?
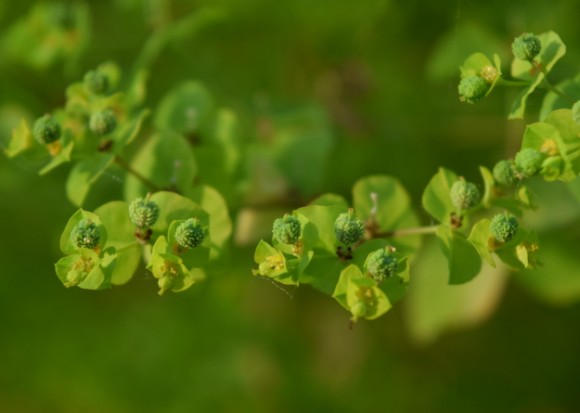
5,6,580,322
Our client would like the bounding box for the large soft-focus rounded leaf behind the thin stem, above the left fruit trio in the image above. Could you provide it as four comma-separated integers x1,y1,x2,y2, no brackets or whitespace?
125,132,196,199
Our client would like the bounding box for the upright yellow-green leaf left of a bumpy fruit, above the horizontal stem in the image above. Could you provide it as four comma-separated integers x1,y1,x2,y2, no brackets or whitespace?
422,168,457,224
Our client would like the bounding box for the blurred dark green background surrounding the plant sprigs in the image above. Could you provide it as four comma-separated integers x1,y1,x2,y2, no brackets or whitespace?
0,0,580,413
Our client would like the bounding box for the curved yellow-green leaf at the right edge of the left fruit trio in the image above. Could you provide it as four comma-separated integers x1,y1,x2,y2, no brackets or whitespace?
187,185,233,259
